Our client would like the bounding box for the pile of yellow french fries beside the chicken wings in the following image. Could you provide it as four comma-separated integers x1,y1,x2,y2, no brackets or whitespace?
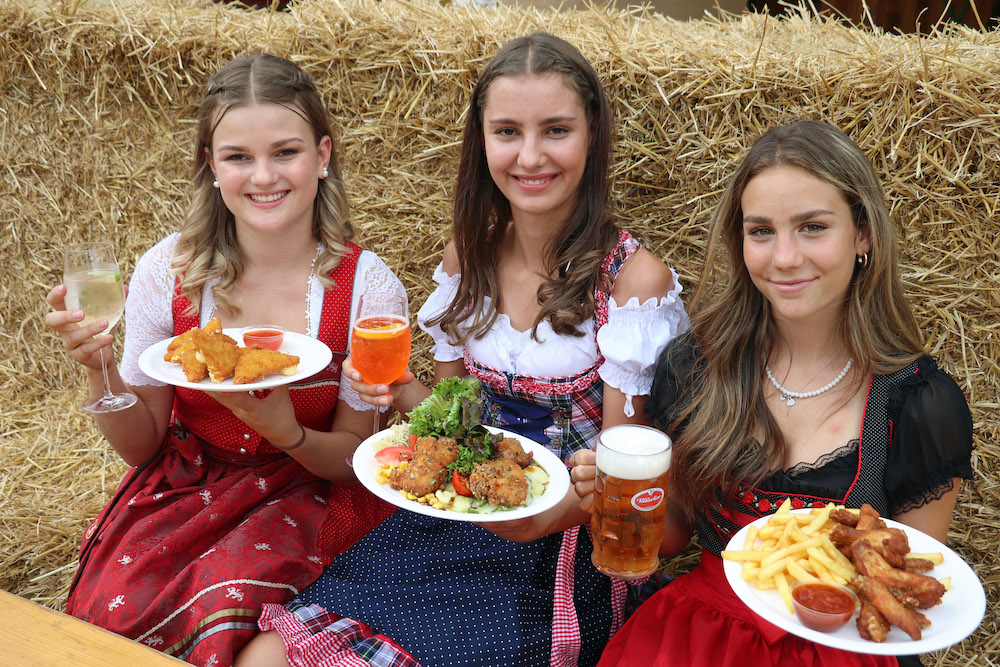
722,498,951,641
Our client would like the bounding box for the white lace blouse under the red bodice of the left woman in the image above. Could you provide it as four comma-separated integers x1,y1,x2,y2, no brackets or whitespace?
120,234,406,411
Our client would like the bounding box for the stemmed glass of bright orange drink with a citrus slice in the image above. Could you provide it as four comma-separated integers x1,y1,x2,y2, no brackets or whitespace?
351,292,410,433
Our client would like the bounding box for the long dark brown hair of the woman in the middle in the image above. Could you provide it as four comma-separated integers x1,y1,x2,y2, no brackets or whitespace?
434,33,618,342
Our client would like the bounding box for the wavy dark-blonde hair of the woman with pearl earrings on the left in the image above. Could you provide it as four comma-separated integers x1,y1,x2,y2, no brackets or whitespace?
171,54,354,312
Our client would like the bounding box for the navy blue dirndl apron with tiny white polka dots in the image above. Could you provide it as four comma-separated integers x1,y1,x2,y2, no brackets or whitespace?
298,510,611,667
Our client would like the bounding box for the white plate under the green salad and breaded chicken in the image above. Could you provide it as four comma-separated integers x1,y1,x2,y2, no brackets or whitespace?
354,426,569,523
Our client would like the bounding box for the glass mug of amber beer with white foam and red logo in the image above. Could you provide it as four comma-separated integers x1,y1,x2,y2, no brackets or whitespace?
590,424,671,579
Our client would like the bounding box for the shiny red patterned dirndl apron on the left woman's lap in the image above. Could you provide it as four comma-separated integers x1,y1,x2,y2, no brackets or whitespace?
66,429,330,667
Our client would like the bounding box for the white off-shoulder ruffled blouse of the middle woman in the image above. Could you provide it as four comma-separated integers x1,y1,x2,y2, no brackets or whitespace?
417,264,688,417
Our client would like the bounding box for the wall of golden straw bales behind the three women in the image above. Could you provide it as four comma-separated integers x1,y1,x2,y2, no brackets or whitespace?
0,0,1000,666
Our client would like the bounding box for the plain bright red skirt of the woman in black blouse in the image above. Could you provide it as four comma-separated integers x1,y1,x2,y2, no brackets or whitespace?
598,551,898,667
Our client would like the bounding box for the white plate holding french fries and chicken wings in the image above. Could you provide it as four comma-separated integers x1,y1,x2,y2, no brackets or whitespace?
722,509,986,655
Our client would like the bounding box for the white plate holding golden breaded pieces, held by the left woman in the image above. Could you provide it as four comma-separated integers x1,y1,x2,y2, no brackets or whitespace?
139,329,333,392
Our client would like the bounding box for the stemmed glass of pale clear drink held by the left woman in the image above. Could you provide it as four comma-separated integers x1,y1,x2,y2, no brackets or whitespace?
63,243,138,413
